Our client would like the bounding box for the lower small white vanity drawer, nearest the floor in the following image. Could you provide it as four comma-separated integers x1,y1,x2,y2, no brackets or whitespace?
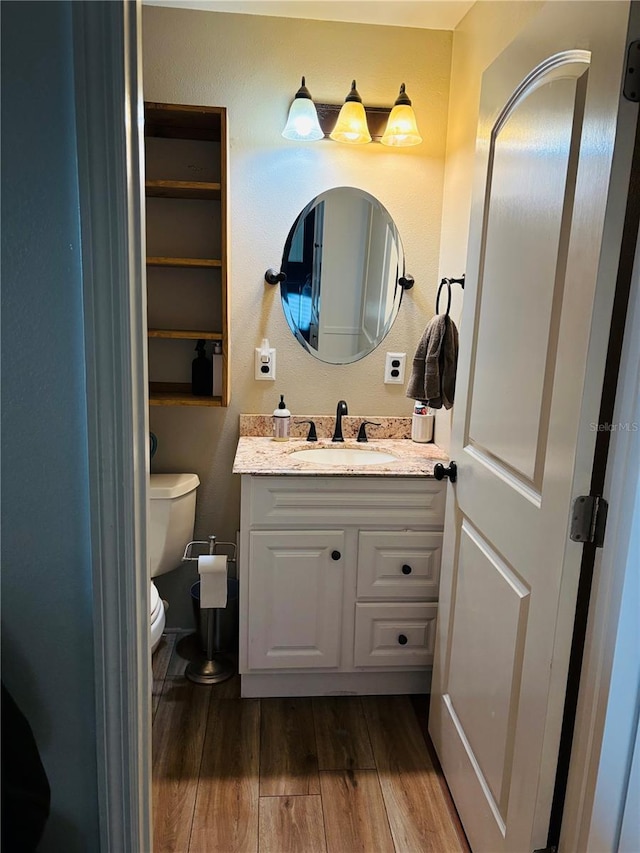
354,602,438,668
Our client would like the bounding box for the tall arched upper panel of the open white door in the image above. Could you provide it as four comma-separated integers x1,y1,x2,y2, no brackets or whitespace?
467,61,589,492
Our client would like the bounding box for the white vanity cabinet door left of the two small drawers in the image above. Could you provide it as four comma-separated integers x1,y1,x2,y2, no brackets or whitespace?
248,530,345,669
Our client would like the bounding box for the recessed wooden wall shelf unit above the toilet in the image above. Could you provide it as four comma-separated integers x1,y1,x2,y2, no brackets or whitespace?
144,102,230,406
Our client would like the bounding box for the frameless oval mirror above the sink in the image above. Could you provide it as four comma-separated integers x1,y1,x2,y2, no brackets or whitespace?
280,187,404,364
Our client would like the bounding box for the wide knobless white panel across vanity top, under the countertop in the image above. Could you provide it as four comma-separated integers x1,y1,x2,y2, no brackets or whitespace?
248,477,445,528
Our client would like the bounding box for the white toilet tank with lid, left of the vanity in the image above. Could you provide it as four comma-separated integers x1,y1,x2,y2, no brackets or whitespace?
148,474,200,578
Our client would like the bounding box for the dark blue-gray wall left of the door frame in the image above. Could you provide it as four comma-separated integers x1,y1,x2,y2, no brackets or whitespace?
2,2,98,853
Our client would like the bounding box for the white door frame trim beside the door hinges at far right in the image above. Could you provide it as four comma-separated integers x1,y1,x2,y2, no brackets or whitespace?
559,130,640,853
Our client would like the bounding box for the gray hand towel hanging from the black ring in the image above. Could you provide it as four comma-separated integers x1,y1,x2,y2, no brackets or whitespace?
407,314,458,409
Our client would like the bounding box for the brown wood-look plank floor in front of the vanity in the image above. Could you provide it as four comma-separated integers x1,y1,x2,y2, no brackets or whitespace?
153,634,469,853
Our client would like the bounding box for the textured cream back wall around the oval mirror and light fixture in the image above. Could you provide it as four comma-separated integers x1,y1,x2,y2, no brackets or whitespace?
143,7,452,626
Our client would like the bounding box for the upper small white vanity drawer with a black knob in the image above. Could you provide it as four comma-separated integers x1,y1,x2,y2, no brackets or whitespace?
358,530,442,600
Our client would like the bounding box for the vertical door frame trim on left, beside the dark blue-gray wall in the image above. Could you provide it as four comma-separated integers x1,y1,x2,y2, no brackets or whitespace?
72,0,152,853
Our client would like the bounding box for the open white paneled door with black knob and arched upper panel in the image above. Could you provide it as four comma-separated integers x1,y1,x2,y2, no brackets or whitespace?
429,2,632,853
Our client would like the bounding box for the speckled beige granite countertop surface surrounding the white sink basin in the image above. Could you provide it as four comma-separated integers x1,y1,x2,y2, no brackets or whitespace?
233,435,448,477
